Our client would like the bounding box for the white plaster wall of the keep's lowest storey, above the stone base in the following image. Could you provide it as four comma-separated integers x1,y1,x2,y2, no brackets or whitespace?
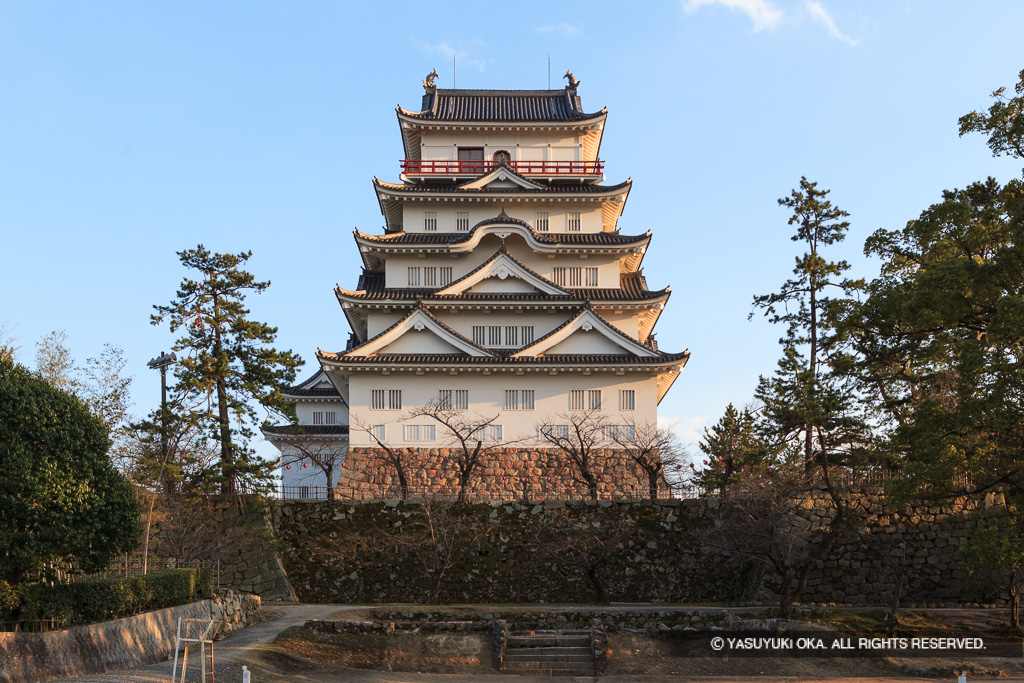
350,370,657,446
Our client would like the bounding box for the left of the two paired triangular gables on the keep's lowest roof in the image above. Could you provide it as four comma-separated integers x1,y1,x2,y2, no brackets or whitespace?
345,308,494,356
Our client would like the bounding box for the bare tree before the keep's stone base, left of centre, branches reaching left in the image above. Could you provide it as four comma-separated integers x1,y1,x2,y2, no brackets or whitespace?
408,400,501,501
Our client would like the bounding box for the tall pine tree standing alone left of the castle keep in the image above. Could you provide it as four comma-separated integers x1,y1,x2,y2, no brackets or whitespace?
152,245,302,494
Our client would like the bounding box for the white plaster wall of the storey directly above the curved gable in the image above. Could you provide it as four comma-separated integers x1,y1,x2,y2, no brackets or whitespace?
401,200,615,232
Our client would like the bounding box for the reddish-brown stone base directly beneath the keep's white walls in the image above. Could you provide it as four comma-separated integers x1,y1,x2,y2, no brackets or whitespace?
335,447,667,501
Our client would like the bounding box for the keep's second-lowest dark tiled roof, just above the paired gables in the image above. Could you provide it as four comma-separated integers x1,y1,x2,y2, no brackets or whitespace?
339,270,668,302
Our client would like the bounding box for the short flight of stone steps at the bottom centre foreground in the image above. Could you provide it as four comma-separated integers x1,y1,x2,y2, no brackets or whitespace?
501,629,597,677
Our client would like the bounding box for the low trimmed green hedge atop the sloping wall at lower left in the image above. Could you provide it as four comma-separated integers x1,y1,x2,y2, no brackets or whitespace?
8,567,211,626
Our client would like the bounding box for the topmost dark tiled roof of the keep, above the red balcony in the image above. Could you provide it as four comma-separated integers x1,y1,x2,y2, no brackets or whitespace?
402,89,603,121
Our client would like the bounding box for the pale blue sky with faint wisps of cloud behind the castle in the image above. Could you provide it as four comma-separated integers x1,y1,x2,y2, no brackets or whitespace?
0,0,1024,453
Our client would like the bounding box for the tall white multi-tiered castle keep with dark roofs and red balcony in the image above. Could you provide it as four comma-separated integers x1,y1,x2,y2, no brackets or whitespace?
266,74,689,497
